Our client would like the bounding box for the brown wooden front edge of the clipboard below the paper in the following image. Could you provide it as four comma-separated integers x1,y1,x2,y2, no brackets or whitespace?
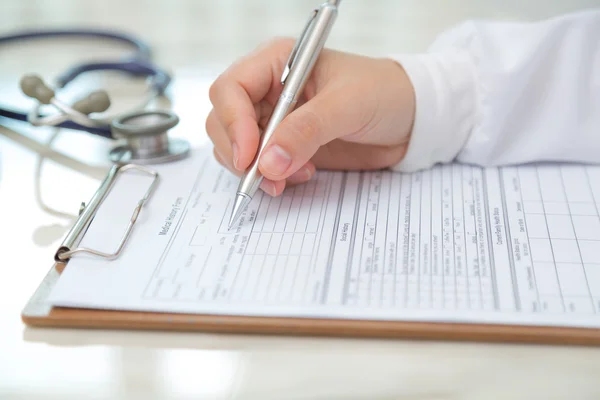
22,308,600,346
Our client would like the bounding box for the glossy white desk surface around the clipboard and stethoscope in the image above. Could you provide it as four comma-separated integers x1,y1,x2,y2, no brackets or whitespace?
0,0,600,400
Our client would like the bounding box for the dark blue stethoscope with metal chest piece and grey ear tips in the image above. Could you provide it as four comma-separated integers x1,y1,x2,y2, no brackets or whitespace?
0,29,190,164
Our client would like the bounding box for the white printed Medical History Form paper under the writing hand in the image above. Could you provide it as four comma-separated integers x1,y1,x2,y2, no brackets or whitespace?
51,153,600,327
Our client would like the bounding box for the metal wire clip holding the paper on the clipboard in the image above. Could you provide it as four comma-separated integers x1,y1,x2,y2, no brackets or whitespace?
54,164,158,262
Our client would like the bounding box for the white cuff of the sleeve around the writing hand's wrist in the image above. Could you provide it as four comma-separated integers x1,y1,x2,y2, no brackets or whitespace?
391,51,476,172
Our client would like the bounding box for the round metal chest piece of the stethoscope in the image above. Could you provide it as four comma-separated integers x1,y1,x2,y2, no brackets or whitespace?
109,111,190,164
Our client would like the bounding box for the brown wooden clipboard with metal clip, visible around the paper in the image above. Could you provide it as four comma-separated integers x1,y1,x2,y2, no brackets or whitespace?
21,164,600,346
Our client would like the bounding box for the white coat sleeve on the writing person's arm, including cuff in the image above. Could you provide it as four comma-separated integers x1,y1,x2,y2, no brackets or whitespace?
392,9,600,171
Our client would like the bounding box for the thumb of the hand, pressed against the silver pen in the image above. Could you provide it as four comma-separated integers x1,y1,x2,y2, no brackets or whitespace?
259,93,348,181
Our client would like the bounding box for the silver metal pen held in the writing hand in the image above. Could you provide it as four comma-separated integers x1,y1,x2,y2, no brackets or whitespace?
229,0,341,229
